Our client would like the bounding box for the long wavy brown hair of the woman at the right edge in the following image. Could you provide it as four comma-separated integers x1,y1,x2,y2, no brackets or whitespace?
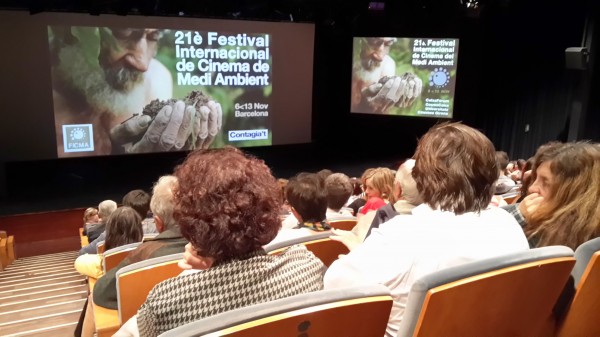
525,142,600,249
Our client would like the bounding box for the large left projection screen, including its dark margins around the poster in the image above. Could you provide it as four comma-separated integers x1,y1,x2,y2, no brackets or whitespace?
0,12,314,160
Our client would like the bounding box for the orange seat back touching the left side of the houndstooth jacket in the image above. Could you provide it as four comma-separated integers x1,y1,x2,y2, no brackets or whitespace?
115,253,183,324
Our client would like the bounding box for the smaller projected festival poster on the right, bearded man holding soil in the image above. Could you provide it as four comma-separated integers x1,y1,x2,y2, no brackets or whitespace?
351,37,458,118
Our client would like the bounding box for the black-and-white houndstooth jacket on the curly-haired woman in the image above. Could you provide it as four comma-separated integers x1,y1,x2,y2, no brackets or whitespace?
137,246,325,336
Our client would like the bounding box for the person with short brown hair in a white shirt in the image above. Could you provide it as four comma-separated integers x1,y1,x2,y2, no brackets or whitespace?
324,123,529,336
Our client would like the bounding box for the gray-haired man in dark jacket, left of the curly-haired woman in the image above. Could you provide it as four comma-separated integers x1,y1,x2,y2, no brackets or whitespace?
93,175,188,309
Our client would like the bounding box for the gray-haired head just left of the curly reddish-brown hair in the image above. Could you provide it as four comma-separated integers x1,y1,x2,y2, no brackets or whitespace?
150,175,177,230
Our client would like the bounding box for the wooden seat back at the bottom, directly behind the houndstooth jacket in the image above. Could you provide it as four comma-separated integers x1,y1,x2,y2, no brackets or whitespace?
160,284,392,337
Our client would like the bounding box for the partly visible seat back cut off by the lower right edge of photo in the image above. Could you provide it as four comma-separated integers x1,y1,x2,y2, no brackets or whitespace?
557,238,600,337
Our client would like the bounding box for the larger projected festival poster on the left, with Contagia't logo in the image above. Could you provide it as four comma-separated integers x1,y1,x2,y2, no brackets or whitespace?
48,26,272,157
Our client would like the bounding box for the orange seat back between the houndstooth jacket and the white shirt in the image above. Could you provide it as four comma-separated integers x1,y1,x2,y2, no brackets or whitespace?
264,232,350,267
